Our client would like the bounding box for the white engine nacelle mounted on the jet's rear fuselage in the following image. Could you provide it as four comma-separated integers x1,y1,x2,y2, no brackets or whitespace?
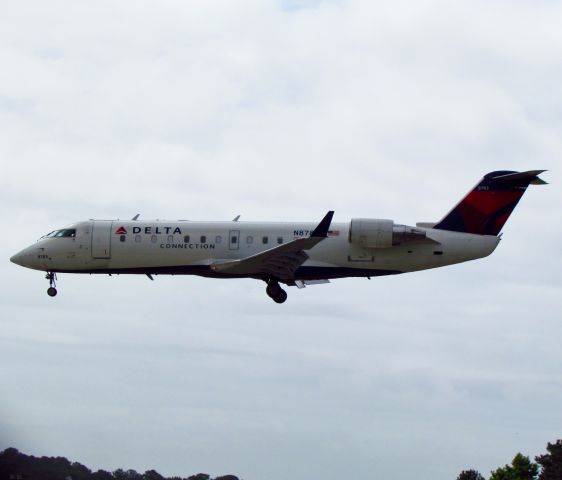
349,218,426,248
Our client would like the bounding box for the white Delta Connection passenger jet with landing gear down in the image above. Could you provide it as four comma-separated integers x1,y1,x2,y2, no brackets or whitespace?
10,170,547,303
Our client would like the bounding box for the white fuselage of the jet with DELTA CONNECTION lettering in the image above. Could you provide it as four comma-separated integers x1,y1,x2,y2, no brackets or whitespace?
12,220,499,280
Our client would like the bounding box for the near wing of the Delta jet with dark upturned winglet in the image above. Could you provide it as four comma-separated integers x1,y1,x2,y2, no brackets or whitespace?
210,211,334,281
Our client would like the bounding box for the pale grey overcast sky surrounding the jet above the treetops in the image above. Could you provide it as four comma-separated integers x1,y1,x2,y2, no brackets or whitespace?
0,0,562,480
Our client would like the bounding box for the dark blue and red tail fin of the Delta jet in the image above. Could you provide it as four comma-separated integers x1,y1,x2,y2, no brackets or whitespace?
433,170,547,235
